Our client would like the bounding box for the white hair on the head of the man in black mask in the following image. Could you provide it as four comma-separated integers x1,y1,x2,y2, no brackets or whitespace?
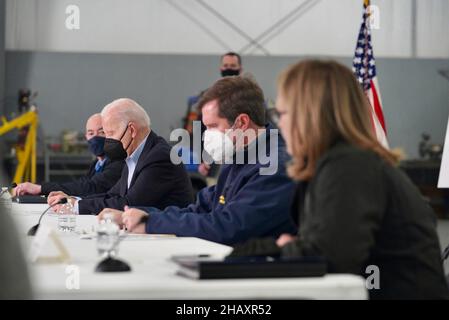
101,98,151,128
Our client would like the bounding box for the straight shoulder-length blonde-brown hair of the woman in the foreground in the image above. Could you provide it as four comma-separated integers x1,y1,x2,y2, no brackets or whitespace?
278,60,398,180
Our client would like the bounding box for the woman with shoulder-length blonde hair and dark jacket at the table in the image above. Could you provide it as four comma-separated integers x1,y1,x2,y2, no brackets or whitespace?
233,60,448,299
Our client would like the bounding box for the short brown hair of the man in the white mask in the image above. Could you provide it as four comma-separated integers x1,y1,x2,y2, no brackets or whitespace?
198,76,265,126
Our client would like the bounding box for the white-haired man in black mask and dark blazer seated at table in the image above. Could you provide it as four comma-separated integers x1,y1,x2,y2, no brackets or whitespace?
48,98,193,214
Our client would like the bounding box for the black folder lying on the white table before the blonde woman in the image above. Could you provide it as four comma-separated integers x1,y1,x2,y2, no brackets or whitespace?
172,255,327,279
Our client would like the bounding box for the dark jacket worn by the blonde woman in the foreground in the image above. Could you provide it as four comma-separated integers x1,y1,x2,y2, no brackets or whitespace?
231,142,448,299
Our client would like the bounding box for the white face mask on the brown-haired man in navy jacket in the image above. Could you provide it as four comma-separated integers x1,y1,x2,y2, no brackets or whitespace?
204,129,234,163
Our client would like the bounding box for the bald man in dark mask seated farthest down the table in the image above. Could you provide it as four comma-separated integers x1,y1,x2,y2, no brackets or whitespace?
14,113,125,197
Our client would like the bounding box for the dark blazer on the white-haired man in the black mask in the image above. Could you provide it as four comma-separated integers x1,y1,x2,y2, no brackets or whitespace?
78,131,193,214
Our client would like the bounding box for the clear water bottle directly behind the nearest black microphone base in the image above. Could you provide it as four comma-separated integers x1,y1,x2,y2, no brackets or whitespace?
97,213,120,256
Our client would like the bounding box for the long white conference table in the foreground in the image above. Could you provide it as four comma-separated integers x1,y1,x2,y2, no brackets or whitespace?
11,203,368,299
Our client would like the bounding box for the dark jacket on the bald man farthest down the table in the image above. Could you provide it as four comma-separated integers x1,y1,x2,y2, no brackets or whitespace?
41,158,125,197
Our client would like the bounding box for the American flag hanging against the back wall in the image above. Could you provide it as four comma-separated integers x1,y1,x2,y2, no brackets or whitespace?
352,0,388,148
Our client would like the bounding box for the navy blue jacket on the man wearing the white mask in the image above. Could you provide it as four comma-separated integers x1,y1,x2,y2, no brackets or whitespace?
141,126,296,245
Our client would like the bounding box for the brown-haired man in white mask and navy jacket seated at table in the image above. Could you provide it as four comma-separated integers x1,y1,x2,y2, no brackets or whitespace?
100,76,296,245
